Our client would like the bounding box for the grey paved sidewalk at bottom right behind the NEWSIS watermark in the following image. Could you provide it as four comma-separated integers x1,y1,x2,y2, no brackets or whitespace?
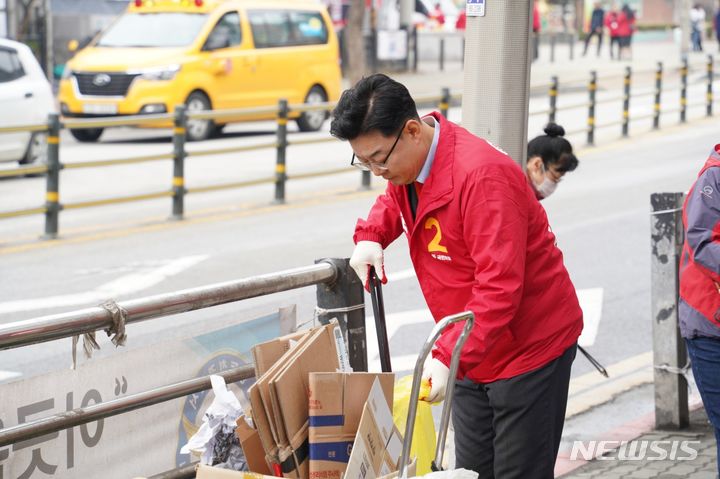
555,404,718,479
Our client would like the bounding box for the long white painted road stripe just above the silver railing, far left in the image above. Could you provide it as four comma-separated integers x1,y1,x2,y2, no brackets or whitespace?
0,255,209,314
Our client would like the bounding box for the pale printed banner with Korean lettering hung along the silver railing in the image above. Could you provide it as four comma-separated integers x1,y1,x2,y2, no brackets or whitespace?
0,306,296,479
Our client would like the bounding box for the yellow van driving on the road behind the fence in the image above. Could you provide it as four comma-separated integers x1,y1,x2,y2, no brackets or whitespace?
59,0,341,142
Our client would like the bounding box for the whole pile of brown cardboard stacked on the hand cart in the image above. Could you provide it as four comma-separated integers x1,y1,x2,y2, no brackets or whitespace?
208,323,402,479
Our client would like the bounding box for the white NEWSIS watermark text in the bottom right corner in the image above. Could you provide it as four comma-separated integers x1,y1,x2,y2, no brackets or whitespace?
570,440,700,461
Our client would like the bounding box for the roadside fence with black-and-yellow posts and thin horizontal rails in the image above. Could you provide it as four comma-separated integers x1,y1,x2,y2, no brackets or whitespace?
0,55,717,239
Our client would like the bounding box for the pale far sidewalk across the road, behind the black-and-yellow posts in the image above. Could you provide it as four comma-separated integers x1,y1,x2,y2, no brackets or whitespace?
385,39,720,97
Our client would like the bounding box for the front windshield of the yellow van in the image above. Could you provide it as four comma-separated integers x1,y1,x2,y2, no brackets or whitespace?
96,12,207,47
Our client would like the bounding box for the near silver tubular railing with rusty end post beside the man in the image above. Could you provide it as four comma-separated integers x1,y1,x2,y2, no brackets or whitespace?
0,259,367,479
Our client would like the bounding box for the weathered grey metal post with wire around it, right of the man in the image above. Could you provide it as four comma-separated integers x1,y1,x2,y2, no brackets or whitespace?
650,193,689,428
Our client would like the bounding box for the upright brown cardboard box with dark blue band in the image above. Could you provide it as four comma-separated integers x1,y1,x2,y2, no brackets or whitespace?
309,372,395,479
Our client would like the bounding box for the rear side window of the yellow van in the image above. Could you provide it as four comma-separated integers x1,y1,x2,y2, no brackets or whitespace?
248,10,328,48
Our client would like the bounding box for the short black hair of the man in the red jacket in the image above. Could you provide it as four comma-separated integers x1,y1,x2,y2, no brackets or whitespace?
330,73,420,140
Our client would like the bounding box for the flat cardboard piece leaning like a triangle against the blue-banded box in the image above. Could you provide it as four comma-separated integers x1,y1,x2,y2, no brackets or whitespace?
344,379,403,479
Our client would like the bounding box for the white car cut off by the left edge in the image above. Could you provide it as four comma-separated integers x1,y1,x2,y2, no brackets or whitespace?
0,38,57,164
